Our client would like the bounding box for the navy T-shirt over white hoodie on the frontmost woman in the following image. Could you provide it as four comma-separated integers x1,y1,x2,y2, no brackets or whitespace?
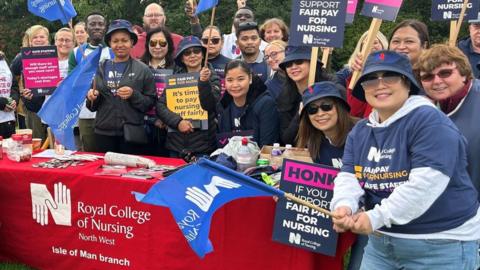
331,96,480,237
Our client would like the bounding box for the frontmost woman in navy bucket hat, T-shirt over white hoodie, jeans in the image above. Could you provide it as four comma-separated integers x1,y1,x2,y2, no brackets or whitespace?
331,51,480,269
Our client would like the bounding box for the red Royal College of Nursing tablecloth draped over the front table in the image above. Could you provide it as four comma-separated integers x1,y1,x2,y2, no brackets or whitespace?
0,153,354,270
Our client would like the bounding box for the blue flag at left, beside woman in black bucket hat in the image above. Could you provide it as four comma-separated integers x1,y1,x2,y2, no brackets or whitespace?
38,47,102,150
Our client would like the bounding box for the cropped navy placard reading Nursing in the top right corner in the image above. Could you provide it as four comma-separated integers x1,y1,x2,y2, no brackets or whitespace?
431,0,480,21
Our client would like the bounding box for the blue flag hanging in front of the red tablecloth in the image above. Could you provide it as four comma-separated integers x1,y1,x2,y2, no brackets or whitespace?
134,159,284,258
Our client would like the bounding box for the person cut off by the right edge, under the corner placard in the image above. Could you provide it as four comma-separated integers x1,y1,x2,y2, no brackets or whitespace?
458,12,480,78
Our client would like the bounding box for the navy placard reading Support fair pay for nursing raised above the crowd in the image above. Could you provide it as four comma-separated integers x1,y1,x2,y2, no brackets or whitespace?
289,0,347,48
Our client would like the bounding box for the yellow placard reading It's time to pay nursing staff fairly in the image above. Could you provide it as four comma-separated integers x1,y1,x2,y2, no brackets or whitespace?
165,73,208,120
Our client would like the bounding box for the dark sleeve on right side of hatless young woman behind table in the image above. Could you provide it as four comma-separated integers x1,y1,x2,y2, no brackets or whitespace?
258,96,279,147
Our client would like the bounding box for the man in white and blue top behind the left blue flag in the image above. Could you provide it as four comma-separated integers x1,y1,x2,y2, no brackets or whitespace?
68,12,113,151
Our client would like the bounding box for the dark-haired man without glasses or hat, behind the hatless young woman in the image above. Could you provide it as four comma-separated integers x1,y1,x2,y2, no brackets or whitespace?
236,22,270,82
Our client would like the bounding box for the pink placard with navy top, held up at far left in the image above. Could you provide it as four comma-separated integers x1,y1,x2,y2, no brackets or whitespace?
22,46,61,96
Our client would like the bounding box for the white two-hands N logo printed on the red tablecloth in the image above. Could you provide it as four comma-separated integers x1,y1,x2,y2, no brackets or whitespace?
30,183,72,226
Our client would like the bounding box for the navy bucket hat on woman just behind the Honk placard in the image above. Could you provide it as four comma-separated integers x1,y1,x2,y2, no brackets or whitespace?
302,81,350,113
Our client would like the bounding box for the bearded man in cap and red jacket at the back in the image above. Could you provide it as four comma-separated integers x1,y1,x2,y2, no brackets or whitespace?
130,3,183,59
